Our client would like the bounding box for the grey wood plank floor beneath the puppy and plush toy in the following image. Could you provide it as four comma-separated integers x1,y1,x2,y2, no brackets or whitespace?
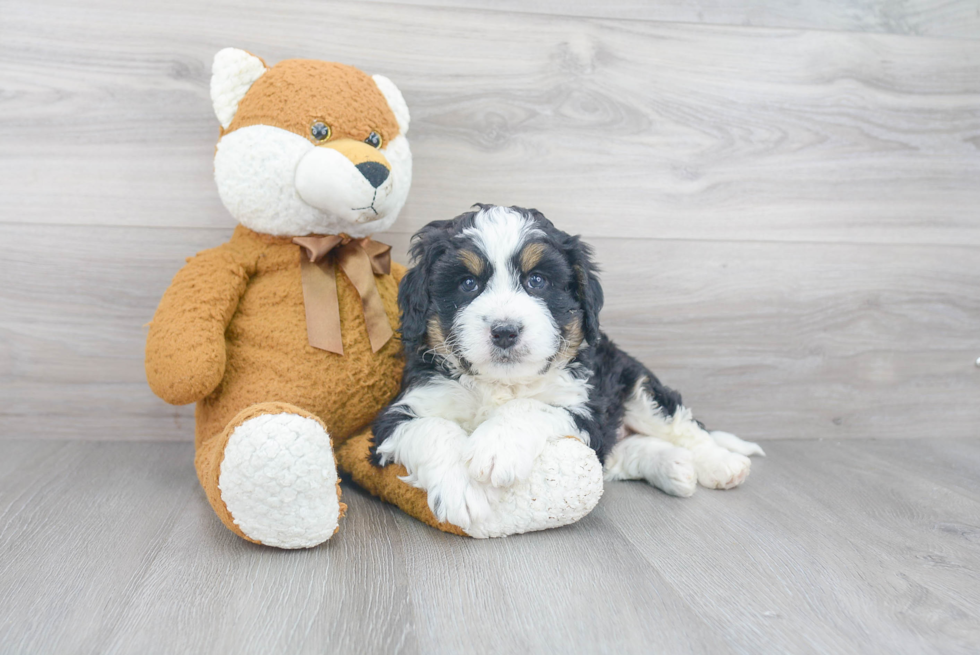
0,438,980,654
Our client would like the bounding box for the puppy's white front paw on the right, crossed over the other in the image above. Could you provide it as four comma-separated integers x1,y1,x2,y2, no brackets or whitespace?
464,423,538,487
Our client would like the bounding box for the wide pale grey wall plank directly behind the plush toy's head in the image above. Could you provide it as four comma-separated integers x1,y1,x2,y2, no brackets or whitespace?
0,0,980,245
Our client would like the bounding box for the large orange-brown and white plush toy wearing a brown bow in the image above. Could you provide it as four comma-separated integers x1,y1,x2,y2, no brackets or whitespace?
145,48,602,548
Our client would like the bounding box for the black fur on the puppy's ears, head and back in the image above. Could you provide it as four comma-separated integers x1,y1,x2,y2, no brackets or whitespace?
371,205,681,463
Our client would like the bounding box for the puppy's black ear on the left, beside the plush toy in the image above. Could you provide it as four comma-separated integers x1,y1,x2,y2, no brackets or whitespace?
398,221,451,355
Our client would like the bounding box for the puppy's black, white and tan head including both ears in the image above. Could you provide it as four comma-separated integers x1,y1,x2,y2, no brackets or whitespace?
399,206,601,380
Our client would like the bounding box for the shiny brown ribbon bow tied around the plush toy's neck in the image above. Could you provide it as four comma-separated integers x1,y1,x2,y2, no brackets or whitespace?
293,234,394,355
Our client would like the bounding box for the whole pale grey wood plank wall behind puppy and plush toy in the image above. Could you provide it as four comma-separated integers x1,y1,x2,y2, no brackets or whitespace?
0,0,980,440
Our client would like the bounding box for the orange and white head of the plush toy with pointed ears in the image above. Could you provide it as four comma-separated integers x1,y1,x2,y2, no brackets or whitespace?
211,48,412,238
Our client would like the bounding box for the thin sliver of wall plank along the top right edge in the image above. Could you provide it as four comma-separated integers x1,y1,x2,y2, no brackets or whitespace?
364,0,980,39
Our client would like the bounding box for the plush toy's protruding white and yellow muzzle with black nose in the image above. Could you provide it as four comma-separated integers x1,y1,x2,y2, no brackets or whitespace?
295,139,394,223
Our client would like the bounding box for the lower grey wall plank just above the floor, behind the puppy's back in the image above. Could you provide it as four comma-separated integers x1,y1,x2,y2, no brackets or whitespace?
0,224,980,439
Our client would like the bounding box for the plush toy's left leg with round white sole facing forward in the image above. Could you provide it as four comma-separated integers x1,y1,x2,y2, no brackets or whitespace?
195,403,347,548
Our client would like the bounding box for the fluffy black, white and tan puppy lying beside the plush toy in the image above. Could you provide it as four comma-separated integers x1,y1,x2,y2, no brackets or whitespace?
373,205,763,529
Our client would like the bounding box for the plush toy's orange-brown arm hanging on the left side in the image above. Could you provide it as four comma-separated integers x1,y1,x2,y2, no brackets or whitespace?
145,247,249,405
